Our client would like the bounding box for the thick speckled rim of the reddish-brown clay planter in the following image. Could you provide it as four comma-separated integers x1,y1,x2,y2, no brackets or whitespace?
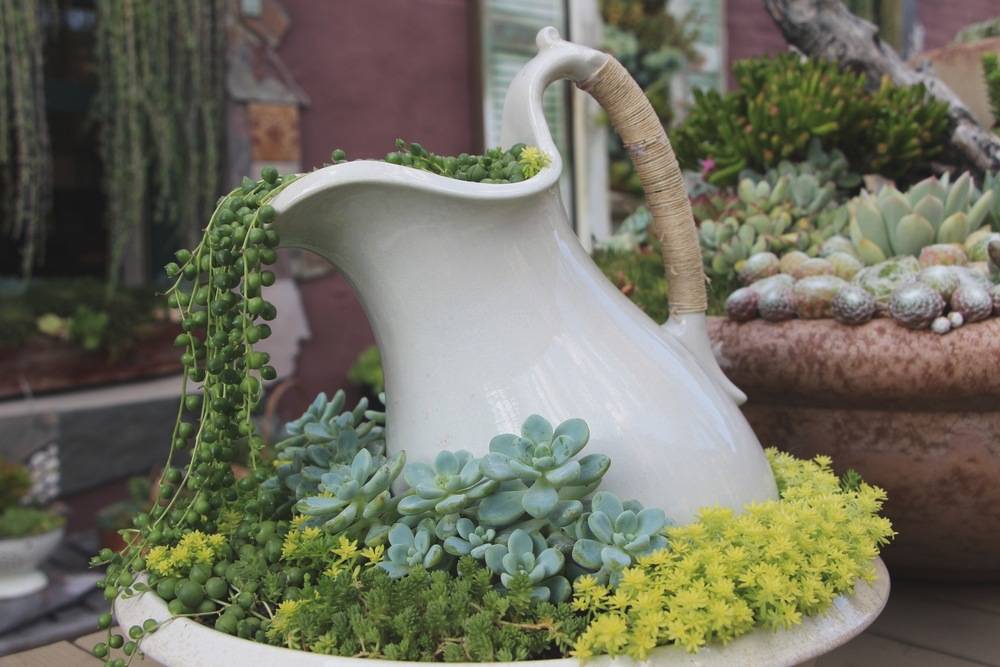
708,317,1000,409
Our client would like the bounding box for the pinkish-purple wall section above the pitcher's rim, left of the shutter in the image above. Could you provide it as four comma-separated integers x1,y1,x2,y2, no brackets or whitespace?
279,0,480,168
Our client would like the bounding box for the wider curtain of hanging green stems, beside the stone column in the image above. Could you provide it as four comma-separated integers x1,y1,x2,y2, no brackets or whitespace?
94,0,226,284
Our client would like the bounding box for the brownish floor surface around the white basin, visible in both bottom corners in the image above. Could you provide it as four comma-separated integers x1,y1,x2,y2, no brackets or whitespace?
0,581,1000,667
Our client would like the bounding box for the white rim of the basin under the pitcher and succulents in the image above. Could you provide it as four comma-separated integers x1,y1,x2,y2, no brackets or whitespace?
114,558,890,667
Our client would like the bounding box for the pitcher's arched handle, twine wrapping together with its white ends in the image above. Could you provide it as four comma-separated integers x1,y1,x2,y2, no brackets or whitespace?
532,28,747,404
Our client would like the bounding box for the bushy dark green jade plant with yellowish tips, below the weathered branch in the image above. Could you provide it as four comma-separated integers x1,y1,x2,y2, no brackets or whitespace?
672,54,950,185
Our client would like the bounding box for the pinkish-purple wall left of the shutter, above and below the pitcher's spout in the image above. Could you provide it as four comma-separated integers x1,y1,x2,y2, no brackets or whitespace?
279,0,481,418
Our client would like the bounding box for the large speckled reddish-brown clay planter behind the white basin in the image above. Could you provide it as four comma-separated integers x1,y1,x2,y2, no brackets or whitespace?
709,318,1000,581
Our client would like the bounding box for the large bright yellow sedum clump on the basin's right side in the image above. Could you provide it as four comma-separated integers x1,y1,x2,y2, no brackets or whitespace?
572,449,895,659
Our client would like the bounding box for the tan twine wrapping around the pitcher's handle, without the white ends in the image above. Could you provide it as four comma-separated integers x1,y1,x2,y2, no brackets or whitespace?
577,56,708,315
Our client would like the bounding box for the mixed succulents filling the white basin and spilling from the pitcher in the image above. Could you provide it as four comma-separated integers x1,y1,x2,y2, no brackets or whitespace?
93,149,892,667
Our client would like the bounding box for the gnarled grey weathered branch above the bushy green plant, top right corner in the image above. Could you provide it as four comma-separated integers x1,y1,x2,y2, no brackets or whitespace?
764,0,1000,172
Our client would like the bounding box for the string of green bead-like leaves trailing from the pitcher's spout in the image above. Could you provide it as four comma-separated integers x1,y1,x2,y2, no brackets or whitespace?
92,167,295,667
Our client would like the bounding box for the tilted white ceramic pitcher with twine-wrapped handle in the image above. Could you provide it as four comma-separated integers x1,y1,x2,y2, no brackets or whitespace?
274,28,776,523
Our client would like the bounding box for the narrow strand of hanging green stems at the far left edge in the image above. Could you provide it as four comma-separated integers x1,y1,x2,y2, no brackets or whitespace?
0,0,52,276
